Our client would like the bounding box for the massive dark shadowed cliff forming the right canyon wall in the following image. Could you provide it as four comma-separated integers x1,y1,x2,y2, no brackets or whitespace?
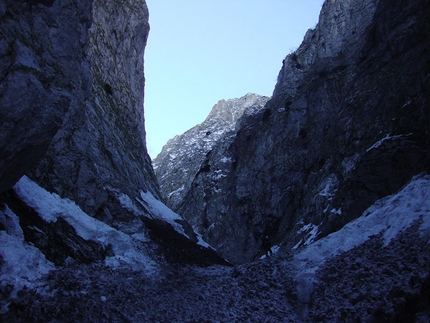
178,0,430,263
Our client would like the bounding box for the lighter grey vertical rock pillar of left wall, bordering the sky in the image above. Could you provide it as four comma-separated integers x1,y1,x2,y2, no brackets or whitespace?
32,0,158,232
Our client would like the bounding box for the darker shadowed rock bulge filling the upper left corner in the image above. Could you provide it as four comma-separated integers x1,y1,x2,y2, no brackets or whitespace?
0,0,91,192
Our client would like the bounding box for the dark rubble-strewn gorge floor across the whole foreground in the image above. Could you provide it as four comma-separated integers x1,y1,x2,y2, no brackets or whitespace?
0,222,430,323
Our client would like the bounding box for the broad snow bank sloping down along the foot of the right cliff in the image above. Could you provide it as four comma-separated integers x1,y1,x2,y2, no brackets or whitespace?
295,175,430,272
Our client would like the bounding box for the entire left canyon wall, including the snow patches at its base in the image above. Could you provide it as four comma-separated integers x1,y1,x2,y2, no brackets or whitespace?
0,0,223,280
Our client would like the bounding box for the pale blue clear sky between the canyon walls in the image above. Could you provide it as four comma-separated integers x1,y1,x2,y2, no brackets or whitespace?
144,0,324,158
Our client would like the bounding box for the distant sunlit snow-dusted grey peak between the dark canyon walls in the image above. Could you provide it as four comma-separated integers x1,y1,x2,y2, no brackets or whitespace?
152,93,269,210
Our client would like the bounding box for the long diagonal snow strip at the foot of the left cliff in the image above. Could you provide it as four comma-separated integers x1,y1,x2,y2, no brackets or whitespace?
14,176,155,273
